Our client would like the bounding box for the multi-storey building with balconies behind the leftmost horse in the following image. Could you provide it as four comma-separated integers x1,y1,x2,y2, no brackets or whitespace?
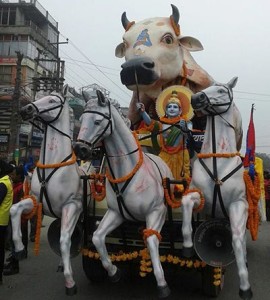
0,0,59,159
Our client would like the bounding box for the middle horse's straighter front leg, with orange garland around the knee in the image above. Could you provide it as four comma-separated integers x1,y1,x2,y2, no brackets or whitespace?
146,205,171,298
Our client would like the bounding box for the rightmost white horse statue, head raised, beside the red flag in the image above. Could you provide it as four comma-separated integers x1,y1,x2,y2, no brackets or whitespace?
182,77,252,300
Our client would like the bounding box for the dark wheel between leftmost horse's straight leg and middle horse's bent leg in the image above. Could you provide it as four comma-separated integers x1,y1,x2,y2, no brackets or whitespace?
82,255,107,283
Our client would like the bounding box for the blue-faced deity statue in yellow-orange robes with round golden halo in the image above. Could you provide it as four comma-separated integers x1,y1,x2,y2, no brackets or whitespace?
137,86,193,182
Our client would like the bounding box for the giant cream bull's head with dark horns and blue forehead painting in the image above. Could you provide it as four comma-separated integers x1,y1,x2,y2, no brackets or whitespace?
115,5,203,97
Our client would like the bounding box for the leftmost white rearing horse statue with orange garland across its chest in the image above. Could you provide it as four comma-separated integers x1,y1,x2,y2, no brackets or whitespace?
10,88,92,295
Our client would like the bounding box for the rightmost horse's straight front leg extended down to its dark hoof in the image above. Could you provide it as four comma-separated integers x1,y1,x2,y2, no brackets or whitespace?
229,201,252,300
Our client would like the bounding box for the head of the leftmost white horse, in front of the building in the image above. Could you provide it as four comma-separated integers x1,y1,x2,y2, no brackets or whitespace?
20,86,68,123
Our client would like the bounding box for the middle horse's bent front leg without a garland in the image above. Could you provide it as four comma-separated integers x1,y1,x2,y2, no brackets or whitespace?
92,209,123,282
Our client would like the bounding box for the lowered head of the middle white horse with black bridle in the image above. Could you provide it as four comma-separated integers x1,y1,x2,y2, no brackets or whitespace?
74,90,113,160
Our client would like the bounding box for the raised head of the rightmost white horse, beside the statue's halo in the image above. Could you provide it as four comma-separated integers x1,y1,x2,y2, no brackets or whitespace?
191,77,238,115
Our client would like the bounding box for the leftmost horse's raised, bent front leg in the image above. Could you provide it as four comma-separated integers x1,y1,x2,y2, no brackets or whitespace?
10,198,34,258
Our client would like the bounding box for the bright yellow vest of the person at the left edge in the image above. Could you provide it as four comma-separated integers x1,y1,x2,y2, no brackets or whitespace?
0,175,13,226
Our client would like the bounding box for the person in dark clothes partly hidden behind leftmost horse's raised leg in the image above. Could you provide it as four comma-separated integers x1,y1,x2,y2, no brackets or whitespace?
3,166,28,276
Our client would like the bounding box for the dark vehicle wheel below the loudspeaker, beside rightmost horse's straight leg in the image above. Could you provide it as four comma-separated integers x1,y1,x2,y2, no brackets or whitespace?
202,265,224,297
